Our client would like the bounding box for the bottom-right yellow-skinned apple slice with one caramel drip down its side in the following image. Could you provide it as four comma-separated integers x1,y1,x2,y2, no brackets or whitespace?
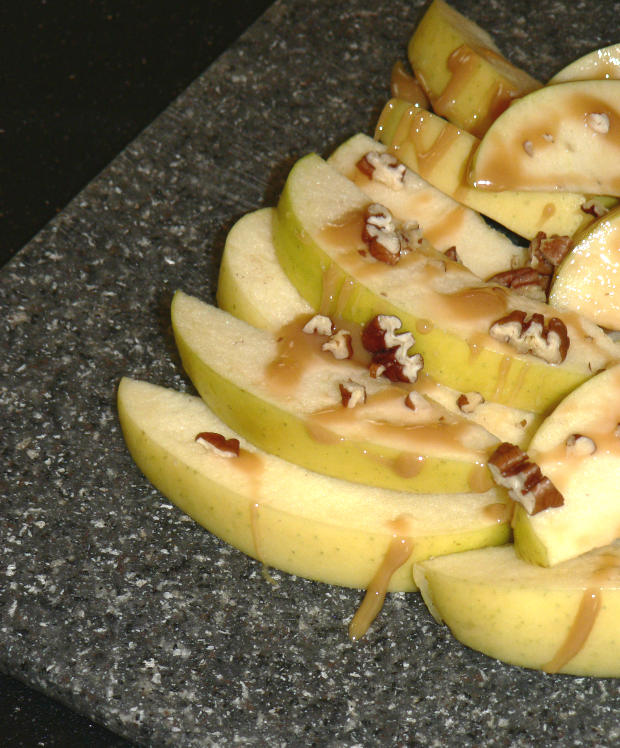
414,543,620,677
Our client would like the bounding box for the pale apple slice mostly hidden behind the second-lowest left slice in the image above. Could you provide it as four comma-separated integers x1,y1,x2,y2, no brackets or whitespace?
218,199,541,448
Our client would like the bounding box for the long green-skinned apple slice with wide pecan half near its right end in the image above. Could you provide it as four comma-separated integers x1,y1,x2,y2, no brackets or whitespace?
274,154,618,413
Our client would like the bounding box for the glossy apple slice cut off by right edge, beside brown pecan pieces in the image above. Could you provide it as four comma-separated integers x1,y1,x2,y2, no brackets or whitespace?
549,208,620,330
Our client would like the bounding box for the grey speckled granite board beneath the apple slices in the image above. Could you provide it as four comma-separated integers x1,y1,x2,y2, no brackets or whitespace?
0,0,620,746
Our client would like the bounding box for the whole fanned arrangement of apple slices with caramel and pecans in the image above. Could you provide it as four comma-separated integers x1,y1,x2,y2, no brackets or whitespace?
118,0,620,676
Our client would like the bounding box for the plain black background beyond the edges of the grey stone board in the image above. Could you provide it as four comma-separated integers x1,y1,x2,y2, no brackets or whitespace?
0,0,271,748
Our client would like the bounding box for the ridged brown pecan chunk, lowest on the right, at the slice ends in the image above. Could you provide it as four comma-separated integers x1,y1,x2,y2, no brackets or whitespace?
488,442,564,514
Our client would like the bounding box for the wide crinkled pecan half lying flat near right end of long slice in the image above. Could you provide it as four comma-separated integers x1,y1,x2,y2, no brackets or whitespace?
489,310,570,364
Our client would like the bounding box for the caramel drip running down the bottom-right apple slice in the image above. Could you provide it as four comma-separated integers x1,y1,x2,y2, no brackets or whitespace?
541,553,620,673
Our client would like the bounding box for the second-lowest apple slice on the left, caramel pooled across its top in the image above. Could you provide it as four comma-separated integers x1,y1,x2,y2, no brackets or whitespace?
172,292,497,493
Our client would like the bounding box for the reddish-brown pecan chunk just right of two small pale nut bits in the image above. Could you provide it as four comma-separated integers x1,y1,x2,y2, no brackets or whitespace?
362,314,424,382
